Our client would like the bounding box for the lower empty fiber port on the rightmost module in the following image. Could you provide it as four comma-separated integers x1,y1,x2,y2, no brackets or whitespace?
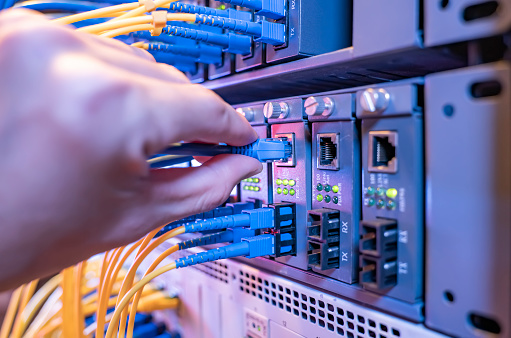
360,255,397,291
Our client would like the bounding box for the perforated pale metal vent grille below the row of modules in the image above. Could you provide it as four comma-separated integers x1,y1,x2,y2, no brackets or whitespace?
238,269,401,338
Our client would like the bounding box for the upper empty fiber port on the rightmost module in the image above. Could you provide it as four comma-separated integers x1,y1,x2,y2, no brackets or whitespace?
359,218,398,258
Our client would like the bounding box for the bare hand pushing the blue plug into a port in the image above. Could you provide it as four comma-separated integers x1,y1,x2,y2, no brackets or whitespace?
0,10,262,290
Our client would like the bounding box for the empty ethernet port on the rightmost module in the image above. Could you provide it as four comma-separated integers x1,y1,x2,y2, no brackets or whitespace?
368,131,398,174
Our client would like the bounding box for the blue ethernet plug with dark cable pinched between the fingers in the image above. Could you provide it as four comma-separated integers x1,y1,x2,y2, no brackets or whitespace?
160,138,293,162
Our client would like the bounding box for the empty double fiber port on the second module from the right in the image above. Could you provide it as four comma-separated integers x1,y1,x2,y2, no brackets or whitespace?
307,209,341,270
